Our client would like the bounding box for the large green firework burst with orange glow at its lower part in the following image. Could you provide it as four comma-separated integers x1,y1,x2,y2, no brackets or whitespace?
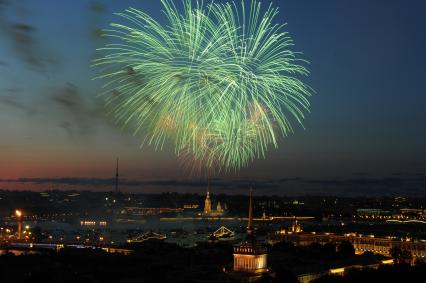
94,0,311,171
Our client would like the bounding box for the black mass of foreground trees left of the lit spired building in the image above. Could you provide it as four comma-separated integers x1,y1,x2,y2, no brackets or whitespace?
0,241,232,283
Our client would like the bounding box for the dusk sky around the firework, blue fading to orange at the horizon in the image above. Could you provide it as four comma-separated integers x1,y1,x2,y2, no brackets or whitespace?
0,0,426,196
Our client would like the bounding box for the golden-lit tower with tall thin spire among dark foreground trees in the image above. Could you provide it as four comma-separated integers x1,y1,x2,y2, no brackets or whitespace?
229,191,269,282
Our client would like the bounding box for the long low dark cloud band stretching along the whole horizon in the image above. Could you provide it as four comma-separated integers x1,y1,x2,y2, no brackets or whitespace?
0,177,426,197
